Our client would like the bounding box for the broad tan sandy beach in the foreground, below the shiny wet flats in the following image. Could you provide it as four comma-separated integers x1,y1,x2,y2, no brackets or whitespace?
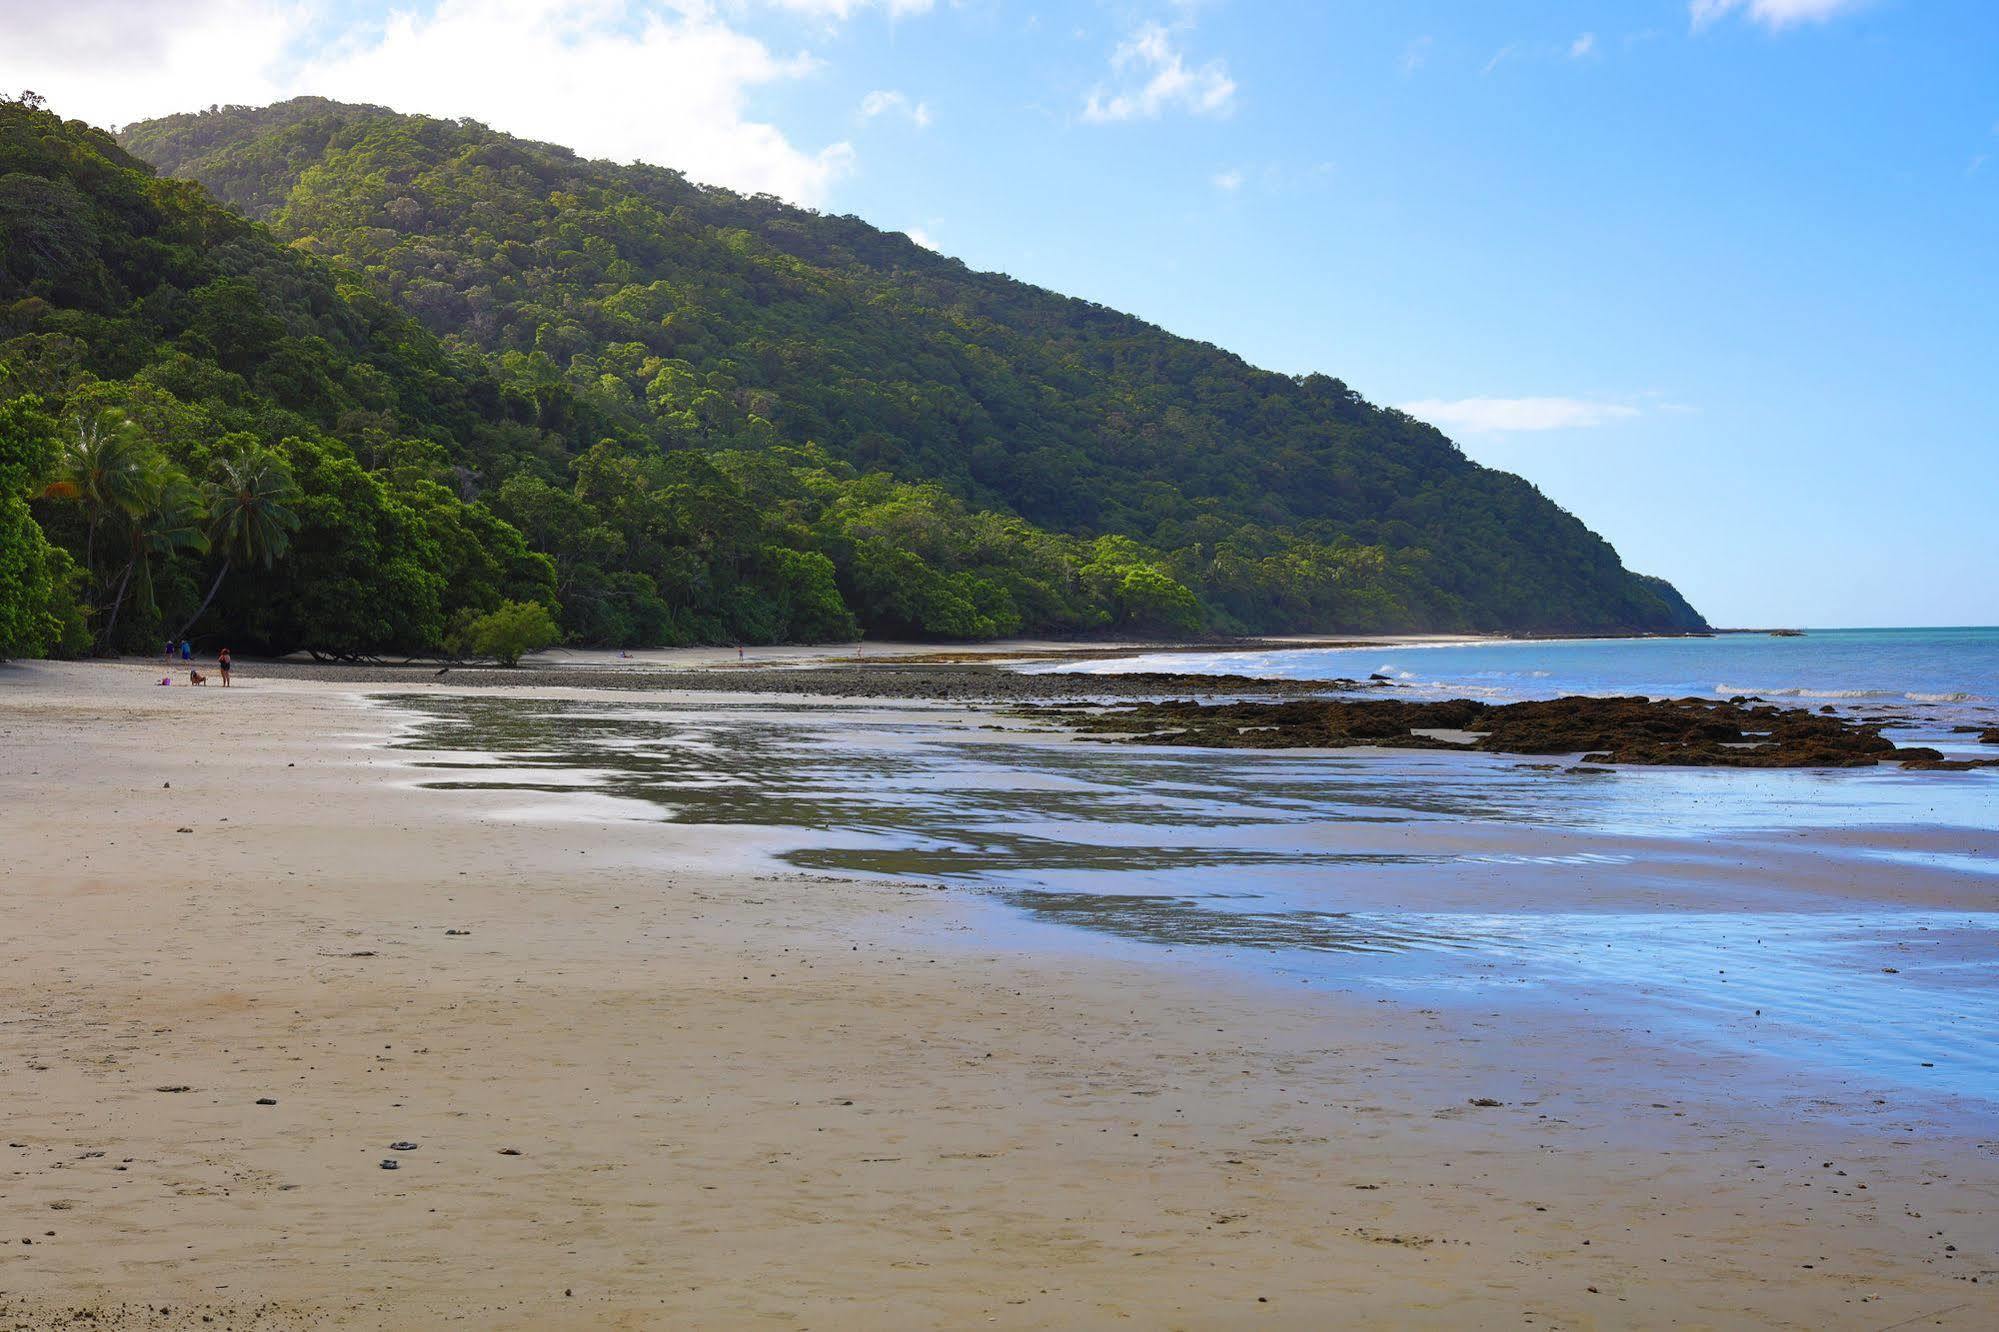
0,666,1999,1328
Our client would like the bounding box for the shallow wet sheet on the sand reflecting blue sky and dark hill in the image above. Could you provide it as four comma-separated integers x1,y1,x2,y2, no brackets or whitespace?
384,696,1999,1100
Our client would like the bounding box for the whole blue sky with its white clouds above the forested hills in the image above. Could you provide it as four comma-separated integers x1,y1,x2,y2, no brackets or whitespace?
0,0,1999,624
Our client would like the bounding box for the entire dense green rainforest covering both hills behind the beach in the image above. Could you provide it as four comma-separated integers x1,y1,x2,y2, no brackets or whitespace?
0,88,1701,656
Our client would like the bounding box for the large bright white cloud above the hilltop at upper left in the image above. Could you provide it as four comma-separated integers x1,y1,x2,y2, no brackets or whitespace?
0,0,875,204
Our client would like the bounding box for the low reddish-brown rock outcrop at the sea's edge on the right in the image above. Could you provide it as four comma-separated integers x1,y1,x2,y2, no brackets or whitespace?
1033,696,1999,770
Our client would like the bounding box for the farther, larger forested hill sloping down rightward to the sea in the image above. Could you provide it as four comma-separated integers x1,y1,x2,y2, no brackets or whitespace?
122,98,1701,632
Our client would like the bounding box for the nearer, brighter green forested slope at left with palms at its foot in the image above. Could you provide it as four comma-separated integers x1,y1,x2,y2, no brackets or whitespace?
0,100,1231,656
